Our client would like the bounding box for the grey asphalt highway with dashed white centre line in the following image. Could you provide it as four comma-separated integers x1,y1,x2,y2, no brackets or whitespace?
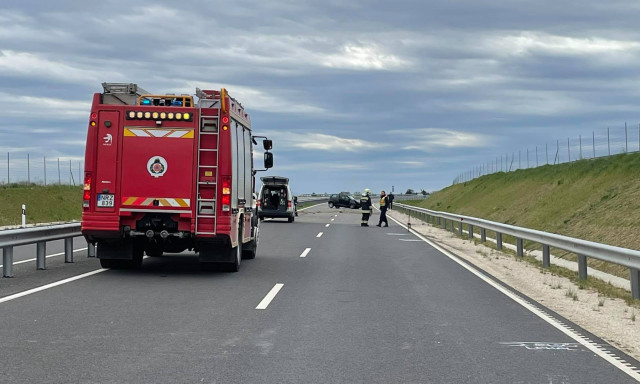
0,204,640,384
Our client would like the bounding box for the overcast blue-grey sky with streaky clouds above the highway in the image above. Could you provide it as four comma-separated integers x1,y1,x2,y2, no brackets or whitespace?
0,0,640,194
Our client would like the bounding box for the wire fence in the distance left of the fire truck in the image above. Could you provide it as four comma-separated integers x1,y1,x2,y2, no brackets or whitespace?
0,152,84,186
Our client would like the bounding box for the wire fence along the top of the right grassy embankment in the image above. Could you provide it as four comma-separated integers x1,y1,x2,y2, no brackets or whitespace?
453,123,640,184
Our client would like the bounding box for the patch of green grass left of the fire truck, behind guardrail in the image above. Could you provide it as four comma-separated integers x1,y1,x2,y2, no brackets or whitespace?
0,184,82,226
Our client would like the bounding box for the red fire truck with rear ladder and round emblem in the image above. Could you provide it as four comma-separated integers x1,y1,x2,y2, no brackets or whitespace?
82,83,273,271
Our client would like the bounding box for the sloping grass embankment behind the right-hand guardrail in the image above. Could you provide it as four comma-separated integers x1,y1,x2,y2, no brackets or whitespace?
411,153,640,279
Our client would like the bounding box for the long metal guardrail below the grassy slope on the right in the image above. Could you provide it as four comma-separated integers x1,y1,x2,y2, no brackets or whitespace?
394,203,640,299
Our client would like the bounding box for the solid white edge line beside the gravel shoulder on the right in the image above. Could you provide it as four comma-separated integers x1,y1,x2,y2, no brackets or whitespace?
389,216,640,382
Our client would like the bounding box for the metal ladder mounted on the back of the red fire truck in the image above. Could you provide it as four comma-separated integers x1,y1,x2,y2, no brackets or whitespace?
195,88,220,236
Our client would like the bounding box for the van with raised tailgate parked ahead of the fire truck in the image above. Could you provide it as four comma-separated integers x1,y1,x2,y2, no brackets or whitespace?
258,176,298,223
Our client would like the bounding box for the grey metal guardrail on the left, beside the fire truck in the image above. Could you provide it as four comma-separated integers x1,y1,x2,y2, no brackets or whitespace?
0,223,95,277
